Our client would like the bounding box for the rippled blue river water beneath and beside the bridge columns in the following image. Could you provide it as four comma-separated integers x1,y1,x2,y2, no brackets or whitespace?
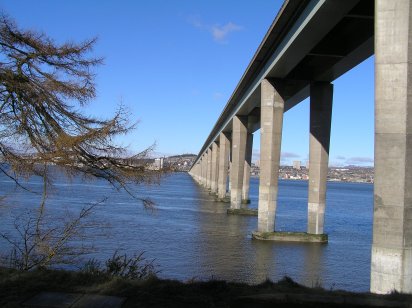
0,173,373,291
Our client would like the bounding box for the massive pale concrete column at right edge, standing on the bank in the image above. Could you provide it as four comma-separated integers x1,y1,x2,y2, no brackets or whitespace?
371,0,412,293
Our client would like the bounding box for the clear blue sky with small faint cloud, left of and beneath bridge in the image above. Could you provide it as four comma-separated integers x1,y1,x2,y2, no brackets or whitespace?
0,0,374,165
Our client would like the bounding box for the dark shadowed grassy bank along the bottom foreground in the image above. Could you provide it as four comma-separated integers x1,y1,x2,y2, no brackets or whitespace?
0,268,412,308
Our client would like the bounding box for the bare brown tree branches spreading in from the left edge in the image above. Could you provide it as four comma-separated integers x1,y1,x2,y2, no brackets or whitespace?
0,15,164,200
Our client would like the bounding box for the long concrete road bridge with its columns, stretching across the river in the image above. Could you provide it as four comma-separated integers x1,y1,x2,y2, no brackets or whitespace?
190,0,412,293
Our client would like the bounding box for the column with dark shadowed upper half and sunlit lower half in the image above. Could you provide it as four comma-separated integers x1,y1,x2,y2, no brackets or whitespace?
308,82,333,234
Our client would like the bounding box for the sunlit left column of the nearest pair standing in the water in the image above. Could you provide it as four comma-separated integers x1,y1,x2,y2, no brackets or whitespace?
258,79,284,232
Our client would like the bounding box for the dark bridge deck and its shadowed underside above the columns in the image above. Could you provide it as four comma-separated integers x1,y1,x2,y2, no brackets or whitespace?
199,0,374,146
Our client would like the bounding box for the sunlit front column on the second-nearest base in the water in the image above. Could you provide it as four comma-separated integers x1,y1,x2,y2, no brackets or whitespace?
230,116,247,209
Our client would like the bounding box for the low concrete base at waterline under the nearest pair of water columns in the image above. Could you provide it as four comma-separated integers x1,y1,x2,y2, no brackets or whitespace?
252,231,328,243
